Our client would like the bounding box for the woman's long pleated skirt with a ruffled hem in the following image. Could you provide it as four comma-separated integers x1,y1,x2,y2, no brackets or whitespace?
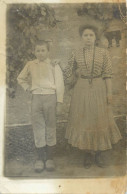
65,78,121,151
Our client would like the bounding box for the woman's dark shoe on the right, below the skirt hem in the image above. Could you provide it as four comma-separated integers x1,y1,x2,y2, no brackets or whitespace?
95,152,107,168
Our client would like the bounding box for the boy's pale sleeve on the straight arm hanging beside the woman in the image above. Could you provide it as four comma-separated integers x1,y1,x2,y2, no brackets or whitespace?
55,65,64,103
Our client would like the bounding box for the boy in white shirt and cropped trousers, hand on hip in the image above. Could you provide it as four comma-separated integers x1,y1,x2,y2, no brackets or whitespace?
17,40,64,172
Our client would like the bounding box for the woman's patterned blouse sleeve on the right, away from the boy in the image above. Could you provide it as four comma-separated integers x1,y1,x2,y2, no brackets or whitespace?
102,50,112,79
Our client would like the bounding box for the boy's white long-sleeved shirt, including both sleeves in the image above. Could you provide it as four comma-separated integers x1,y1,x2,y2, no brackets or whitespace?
17,58,64,102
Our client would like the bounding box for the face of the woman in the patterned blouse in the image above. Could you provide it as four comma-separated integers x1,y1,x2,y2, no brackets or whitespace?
82,29,96,46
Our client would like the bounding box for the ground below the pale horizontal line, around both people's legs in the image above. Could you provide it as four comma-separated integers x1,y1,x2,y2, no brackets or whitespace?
4,119,126,178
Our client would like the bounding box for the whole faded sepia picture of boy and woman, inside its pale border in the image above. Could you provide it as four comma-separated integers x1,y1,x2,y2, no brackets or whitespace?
4,3,127,179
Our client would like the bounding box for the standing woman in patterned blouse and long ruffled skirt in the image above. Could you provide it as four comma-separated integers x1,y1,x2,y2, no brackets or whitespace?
65,25,121,168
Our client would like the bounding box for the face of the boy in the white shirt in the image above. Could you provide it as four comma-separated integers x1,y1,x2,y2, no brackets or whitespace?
35,45,49,61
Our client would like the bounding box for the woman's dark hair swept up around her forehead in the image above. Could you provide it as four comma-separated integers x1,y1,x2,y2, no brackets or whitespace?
79,25,98,39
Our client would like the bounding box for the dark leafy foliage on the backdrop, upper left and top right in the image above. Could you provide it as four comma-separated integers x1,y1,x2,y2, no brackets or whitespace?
7,3,125,90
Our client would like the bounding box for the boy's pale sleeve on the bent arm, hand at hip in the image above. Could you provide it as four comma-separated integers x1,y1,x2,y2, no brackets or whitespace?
17,62,30,91
